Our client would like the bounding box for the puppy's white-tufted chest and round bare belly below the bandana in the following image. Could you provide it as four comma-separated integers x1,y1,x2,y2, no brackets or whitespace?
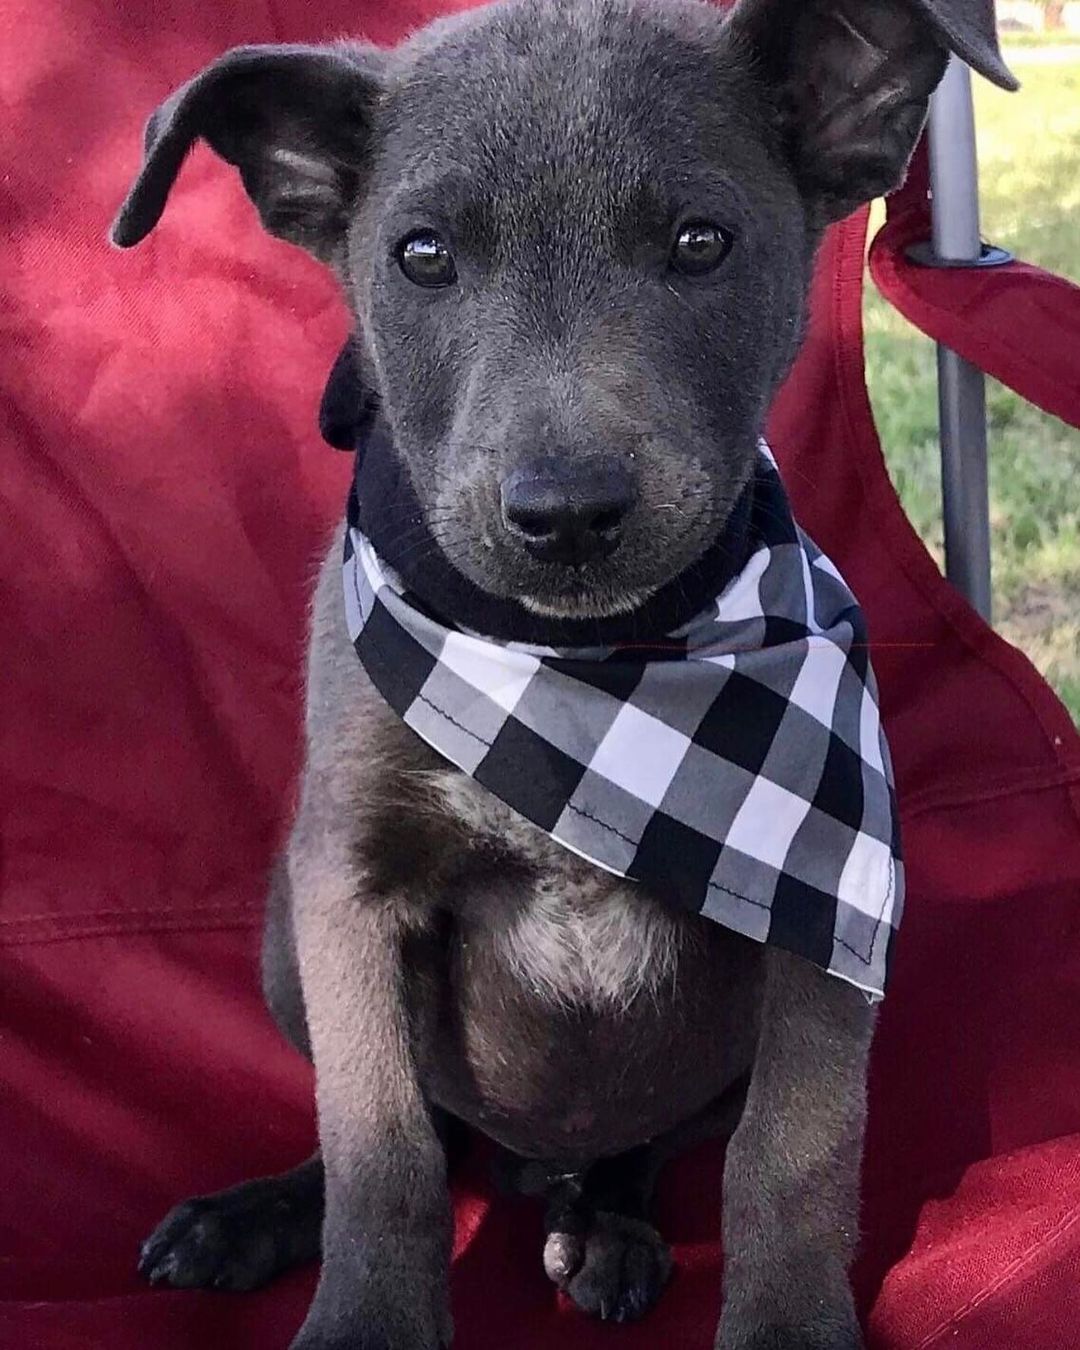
407,771,756,1160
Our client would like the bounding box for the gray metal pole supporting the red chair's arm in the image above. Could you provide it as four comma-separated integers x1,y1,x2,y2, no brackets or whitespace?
929,57,991,621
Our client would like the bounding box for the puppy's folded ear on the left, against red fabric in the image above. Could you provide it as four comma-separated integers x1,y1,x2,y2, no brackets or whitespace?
112,43,385,262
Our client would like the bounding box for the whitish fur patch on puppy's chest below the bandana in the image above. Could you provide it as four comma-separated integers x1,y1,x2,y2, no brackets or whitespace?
427,770,686,1008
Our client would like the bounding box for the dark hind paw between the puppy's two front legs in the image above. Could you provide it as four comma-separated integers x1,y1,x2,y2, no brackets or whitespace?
544,1211,671,1322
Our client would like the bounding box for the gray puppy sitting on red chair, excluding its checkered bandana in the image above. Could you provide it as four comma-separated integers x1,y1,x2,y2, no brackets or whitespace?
113,0,1014,1350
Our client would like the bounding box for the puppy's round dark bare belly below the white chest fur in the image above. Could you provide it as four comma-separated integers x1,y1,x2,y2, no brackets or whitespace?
421,895,760,1166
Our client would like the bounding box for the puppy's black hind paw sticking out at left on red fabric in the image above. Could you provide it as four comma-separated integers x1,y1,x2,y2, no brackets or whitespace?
139,1177,320,1291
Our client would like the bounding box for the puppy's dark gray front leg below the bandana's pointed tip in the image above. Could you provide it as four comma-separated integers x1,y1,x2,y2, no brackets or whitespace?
717,950,873,1350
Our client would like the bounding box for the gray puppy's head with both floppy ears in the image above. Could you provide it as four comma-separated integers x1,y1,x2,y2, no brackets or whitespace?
113,0,1014,618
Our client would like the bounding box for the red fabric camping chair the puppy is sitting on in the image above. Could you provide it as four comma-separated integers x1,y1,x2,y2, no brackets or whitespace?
0,0,1080,1350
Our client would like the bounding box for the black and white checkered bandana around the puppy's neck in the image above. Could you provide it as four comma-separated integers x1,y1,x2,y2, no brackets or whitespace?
344,443,903,998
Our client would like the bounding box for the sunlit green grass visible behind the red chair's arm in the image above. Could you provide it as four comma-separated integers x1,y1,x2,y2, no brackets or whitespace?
865,43,1080,722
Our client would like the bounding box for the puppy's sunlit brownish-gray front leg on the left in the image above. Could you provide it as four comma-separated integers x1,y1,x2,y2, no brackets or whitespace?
289,822,451,1350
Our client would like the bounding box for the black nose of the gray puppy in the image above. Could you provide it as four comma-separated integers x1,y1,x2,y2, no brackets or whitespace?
502,459,636,566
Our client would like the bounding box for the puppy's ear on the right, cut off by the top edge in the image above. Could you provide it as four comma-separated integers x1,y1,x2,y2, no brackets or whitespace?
729,0,1018,221
